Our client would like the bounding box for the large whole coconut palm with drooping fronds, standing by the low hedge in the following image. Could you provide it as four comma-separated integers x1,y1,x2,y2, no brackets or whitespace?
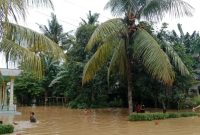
82,0,193,113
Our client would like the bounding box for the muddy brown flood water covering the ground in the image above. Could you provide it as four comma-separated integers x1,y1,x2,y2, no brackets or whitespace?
0,107,200,135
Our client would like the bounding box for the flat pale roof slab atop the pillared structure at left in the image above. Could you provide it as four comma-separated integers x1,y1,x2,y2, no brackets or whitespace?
0,68,22,76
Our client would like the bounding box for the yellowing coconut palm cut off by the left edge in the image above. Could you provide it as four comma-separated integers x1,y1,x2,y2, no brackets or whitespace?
0,0,65,75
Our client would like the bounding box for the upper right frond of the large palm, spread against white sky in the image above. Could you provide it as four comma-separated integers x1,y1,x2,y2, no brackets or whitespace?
141,0,194,21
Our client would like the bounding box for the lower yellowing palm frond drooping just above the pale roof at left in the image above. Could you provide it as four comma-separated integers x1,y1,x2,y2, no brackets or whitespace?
0,39,42,77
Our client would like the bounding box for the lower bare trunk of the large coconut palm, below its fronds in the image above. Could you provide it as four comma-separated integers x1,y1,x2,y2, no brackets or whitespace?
127,60,133,114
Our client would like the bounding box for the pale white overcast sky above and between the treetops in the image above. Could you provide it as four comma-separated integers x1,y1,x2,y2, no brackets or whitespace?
0,0,200,68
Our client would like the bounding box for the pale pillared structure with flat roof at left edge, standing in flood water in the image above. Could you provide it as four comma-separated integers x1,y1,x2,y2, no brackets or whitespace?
0,68,22,112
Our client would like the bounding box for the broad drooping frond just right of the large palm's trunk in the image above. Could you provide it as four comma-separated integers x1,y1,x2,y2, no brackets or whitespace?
133,29,175,86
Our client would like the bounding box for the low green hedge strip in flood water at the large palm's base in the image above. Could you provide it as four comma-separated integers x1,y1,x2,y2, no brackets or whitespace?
128,112,198,121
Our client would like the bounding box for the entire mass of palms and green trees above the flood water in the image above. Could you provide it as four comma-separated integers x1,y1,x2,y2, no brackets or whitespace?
0,0,200,117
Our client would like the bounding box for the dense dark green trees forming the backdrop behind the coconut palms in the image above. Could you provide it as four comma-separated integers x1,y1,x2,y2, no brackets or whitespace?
12,7,200,109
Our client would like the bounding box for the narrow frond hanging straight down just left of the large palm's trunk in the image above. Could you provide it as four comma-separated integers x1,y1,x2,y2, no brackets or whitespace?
107,40,126,83
